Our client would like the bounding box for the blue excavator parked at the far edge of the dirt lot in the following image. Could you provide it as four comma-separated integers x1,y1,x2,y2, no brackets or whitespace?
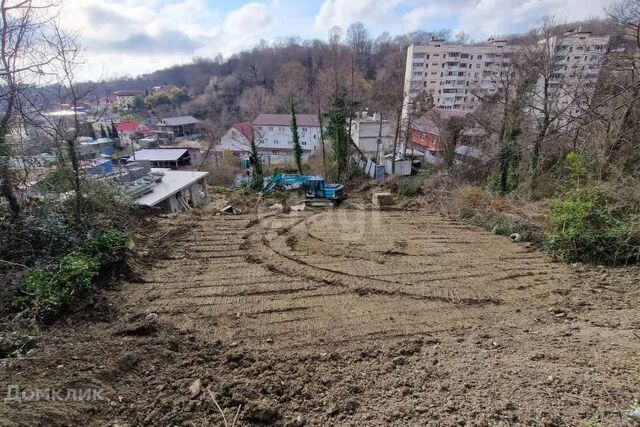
261,173,345,206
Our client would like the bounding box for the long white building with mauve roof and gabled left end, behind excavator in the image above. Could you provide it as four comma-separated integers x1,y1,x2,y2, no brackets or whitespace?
215,114,320,164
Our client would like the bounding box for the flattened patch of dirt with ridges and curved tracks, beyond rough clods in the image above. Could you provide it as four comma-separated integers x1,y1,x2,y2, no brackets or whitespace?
125,211,576,351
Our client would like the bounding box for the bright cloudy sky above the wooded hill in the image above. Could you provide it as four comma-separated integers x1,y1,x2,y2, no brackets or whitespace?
61,0,612,78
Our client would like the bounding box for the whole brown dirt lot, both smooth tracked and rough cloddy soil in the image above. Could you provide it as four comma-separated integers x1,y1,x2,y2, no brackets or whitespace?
0,209,640,426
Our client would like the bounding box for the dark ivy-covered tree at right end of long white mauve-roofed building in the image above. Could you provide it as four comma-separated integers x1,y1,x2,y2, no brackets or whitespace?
327,86,349,181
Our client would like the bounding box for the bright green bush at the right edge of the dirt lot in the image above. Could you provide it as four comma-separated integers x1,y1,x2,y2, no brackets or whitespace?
545,186,640,265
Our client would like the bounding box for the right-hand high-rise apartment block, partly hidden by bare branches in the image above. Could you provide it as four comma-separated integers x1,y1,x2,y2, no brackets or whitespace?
538,30,609,121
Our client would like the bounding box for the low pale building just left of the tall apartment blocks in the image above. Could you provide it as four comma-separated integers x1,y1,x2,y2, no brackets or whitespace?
351,111,394,164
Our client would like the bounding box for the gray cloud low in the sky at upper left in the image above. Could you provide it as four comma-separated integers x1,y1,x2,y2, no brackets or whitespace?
91,31,202,55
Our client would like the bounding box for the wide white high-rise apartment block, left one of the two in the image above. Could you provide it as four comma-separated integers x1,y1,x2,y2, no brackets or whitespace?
403,39,510,116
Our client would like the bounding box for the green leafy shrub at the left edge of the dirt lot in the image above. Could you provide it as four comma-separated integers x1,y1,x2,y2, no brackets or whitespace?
14,229,128,319
